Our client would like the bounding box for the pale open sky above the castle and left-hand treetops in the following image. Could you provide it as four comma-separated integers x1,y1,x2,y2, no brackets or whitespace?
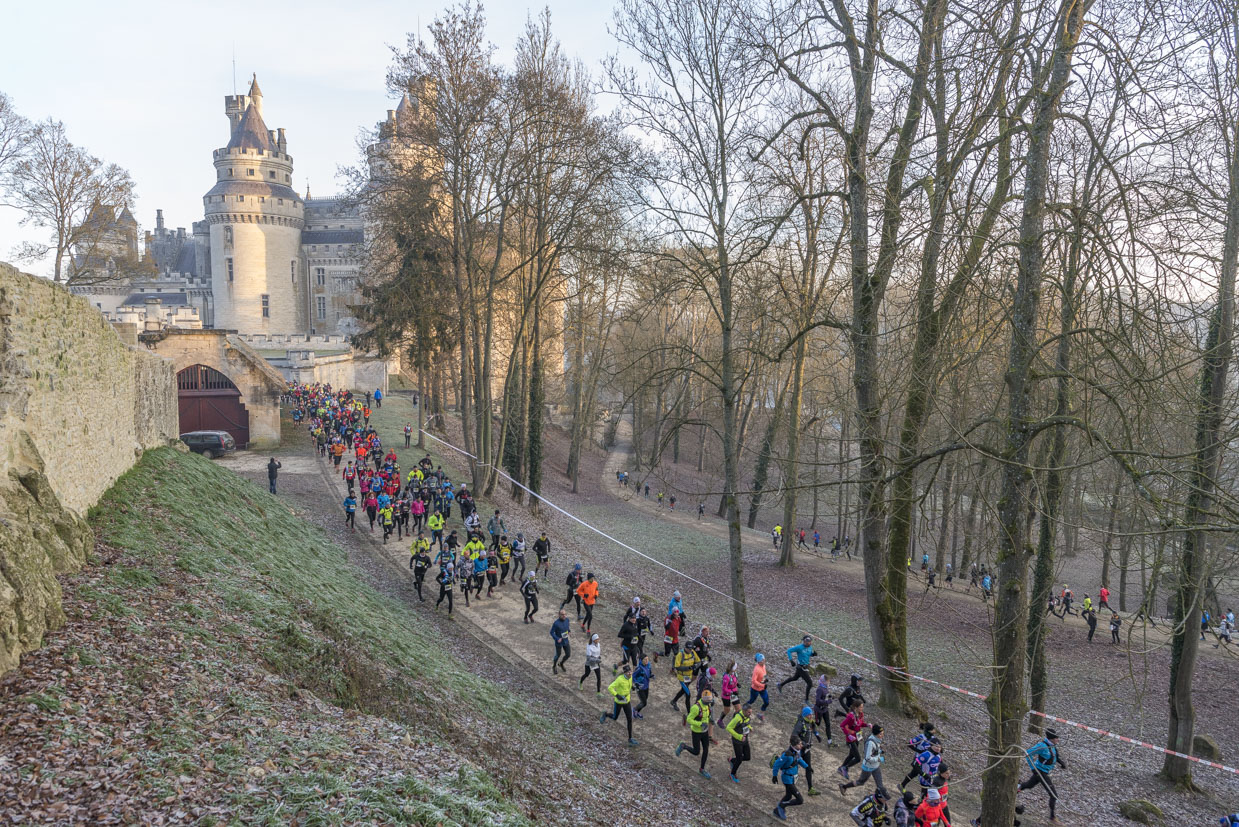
0,0,615,275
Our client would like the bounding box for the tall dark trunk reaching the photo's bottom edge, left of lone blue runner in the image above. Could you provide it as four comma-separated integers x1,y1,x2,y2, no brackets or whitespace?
981,0,1090,825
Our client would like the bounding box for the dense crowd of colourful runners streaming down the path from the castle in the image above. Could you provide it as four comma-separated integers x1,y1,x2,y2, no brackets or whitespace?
286,384,1090,827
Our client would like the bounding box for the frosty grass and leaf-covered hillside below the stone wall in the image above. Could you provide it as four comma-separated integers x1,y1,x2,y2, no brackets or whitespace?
0,449,724,825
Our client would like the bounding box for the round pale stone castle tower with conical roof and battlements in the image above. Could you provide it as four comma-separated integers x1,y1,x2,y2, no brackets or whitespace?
203,77,307,334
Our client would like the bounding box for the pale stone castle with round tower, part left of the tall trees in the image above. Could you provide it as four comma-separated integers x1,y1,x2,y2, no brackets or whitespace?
71,76,366,338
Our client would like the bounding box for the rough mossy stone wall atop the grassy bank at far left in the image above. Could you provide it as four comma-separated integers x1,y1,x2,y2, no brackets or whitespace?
0,263,177,673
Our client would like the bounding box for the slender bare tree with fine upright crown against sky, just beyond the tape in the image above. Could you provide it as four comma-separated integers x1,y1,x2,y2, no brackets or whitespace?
607,0,764,647
